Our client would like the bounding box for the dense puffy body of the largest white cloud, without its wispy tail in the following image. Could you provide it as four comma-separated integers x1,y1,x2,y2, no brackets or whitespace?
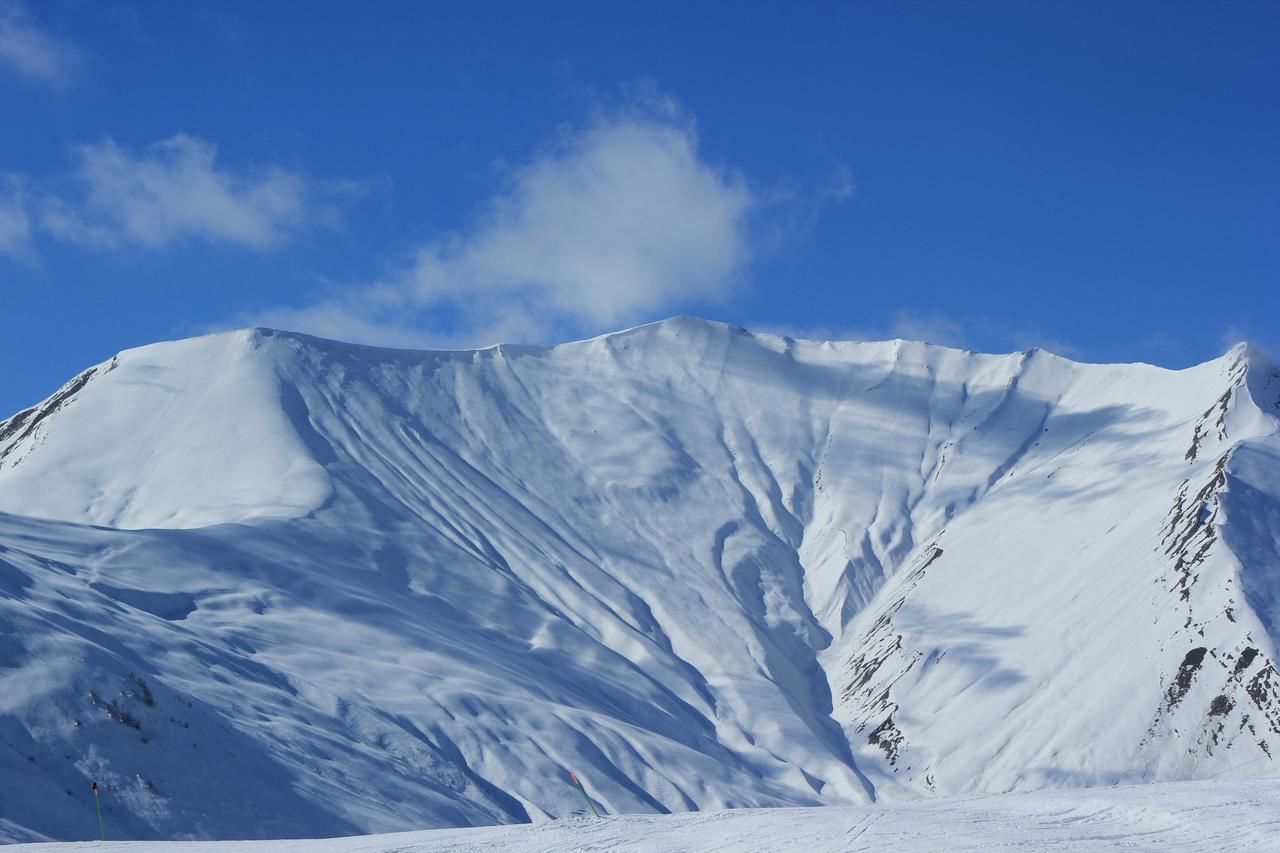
413,119,753,323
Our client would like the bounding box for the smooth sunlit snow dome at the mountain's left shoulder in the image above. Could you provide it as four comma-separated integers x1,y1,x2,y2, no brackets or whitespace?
0,332,329,528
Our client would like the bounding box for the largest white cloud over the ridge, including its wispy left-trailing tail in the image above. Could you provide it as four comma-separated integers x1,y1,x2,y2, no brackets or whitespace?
251,100,762,346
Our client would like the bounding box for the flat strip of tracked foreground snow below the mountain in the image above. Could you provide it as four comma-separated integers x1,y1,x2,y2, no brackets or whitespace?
13,775,1280,853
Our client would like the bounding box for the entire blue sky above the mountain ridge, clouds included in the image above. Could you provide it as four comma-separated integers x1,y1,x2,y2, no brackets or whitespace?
0,0,1280,412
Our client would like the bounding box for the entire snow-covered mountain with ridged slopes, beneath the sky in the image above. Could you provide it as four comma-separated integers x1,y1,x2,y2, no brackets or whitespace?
0,318,1280,839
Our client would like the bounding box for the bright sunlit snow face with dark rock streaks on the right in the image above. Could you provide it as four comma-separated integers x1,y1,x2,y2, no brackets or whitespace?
827,350,1280,792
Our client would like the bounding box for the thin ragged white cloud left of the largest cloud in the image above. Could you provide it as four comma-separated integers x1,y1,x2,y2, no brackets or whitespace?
40,134,342,250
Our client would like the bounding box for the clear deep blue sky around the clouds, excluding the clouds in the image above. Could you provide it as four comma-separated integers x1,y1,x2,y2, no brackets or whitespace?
0,0,1280,416
